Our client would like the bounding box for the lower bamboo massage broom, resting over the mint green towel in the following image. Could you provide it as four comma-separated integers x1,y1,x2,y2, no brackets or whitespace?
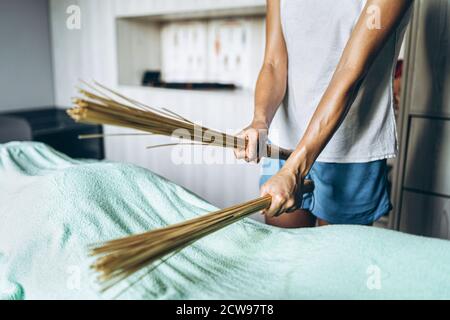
91,181,314,291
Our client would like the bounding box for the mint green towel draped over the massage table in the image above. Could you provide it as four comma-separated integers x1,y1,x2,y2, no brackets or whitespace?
0,143,450,299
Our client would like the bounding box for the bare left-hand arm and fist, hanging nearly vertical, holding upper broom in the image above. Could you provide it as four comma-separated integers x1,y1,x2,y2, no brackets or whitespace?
235,0,287,161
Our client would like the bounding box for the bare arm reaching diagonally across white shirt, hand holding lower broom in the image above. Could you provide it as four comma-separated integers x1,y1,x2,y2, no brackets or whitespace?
261,0,413,216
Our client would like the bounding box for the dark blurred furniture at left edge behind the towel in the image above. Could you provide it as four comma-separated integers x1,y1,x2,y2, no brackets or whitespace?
0,107,104,160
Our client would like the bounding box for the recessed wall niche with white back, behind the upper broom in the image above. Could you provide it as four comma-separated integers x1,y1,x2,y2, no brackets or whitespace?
116,6,265,88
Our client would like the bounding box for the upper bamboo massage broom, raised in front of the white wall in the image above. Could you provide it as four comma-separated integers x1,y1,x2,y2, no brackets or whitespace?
67,83,292,160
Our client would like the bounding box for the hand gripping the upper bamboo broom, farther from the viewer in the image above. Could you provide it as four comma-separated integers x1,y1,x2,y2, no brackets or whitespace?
234,120,269,163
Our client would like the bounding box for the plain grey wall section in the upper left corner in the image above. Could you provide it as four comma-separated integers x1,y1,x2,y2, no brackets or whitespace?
0,0,54,112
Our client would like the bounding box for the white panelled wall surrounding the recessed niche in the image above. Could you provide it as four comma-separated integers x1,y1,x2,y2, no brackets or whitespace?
50,0,265,207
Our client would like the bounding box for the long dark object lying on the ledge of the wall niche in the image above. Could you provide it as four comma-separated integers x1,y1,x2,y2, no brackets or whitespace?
142,71,236,90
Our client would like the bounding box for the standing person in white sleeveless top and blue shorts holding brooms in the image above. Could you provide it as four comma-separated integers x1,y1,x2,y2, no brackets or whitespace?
235,0,413,227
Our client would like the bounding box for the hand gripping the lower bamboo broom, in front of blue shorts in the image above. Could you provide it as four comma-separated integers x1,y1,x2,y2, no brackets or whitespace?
261,163,303,217
